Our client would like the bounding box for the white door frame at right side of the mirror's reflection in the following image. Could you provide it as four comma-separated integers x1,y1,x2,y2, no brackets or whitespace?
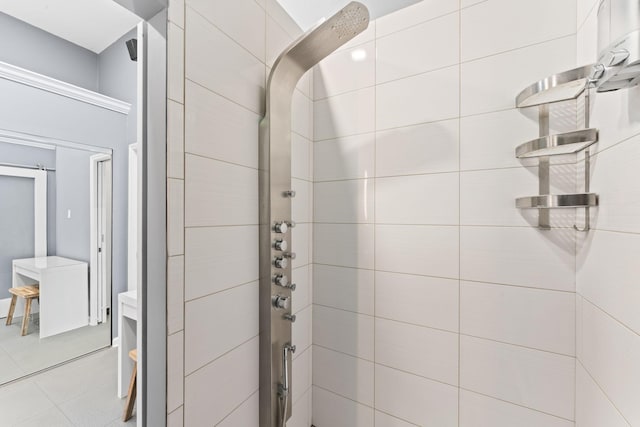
89,154,113,326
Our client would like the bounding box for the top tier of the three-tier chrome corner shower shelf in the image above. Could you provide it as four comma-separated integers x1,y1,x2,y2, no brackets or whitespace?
516,65,593,108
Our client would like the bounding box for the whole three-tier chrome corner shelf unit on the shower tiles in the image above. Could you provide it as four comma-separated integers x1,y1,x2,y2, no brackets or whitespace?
516,65,598,231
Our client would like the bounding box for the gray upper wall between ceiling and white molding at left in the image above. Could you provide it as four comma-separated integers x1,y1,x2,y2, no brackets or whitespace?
0,12,98,91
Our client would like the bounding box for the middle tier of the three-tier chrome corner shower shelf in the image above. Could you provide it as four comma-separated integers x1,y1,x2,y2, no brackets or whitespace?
516,128,598,159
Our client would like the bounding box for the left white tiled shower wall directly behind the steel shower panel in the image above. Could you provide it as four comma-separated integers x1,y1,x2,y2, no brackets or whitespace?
168,0,312,427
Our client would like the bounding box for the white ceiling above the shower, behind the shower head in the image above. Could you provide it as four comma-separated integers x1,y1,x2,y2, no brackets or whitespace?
278,0,421,30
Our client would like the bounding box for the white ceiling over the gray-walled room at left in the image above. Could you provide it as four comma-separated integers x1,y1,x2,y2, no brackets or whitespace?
0,0,141,53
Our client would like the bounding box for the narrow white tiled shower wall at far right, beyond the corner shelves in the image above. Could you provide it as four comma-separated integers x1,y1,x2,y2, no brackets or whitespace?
576,5,640,427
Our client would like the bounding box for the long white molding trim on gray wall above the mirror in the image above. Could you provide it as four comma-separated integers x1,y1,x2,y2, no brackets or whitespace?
0,61,131,114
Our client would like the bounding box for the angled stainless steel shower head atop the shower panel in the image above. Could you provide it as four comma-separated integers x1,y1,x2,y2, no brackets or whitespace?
272,1,369,85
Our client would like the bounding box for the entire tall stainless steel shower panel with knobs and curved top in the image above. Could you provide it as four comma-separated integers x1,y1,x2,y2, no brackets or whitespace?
259,2,369,427
